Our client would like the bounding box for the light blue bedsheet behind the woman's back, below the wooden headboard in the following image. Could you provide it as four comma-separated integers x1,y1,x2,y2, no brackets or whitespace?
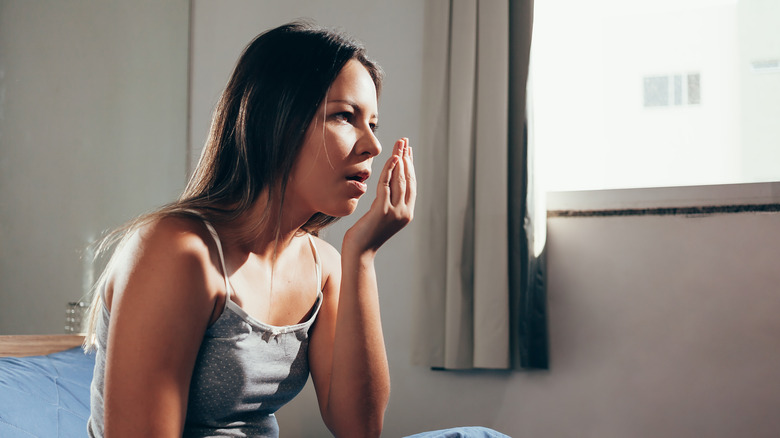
0,348,95,438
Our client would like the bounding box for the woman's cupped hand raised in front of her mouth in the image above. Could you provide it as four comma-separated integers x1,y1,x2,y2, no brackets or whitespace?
342,138,417,253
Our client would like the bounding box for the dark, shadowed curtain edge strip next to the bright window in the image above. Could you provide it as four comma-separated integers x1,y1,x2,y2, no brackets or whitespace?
508,0,550,369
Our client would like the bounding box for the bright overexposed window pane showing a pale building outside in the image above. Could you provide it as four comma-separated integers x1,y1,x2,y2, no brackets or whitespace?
529,0,780,191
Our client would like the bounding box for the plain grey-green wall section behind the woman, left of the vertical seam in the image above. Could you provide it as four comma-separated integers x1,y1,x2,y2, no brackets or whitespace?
0,0,189,334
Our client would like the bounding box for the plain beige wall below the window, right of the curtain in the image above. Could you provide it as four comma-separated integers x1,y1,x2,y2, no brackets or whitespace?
508,213,780,437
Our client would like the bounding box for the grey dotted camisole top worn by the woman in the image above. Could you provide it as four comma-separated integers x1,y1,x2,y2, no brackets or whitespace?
185,304,321,436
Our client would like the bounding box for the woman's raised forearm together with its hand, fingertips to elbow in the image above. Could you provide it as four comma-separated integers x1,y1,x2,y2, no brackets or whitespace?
321,138,417,437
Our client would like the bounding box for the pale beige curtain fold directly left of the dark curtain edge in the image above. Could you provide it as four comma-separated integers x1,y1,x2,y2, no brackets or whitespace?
472,0,511,369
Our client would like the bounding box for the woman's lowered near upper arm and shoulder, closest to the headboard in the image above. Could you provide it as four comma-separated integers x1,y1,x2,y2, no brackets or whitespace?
104,218,216,436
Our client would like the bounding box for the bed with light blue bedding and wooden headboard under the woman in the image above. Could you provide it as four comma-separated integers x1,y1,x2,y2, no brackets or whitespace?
0,335,508,438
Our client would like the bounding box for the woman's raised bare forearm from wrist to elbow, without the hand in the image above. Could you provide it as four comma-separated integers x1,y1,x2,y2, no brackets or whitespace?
328,246,390,436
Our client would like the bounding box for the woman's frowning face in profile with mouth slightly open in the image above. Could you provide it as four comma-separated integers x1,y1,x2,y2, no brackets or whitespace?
285,60,382,217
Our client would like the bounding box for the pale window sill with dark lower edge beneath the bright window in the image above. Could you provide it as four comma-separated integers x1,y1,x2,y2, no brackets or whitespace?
547,182,780,218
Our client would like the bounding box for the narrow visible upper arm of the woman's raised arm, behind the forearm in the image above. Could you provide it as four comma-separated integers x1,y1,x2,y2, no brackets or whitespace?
309,238,341,420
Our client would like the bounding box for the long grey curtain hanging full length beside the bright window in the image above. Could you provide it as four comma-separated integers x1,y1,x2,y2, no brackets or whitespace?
416,0,548,369
